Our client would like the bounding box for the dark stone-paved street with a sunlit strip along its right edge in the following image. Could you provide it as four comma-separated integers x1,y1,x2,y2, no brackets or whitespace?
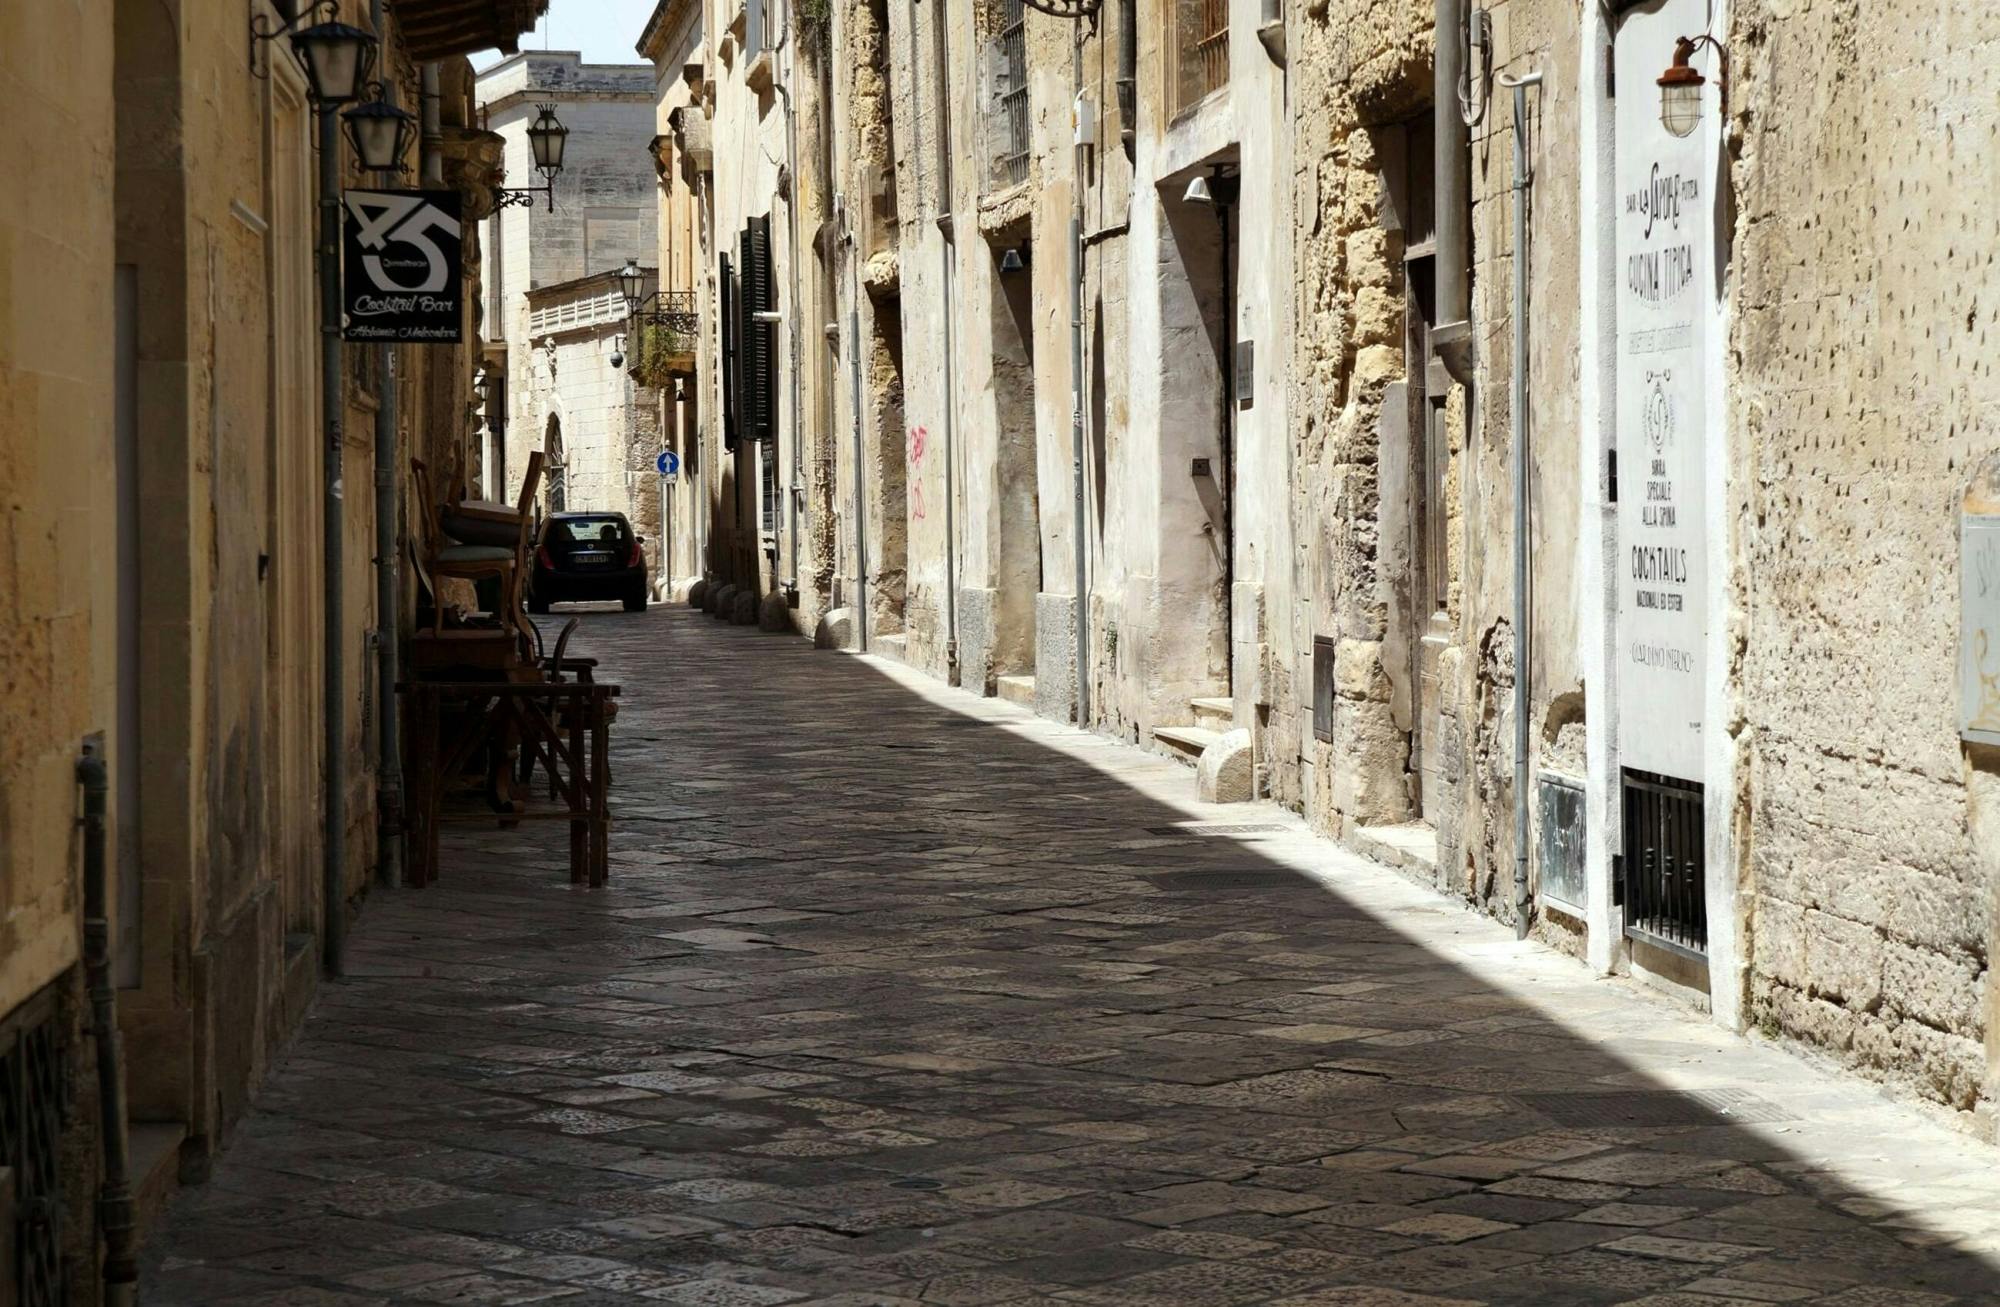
144,608,2000,1307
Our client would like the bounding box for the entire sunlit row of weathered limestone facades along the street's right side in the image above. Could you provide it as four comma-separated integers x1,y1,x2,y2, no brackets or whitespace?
644,0,2000,1129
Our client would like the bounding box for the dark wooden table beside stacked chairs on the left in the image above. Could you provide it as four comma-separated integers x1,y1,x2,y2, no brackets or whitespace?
396,681,618,887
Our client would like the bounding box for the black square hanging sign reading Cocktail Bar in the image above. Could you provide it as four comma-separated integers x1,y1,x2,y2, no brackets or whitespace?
340,190,466,344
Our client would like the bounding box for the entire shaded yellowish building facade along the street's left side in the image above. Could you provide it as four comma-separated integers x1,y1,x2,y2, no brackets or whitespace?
0,0,542,1303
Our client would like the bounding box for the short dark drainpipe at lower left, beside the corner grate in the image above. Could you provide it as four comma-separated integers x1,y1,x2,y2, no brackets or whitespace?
76,737,138,1307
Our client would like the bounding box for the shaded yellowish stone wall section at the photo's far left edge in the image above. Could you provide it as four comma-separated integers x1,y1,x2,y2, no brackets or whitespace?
0,0,116,1013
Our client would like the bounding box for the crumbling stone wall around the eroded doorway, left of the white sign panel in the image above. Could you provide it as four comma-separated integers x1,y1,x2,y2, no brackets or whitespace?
1292,0,1582,939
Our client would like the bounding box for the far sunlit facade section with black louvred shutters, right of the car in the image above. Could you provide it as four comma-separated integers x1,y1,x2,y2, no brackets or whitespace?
640,0,840,632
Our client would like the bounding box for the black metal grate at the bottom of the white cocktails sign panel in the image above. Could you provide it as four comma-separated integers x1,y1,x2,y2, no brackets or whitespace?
1624,771,1708,957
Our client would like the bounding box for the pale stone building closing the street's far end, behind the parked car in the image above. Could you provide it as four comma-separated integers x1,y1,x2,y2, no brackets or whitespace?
478,50,658,515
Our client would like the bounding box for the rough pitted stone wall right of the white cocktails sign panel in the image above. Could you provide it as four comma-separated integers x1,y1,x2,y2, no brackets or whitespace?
1730,0,2000,1111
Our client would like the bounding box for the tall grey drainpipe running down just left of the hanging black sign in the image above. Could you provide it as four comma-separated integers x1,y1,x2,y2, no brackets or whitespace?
320,106,348,975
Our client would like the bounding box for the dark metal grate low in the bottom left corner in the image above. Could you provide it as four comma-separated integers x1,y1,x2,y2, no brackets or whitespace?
0,991,68,1307
